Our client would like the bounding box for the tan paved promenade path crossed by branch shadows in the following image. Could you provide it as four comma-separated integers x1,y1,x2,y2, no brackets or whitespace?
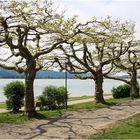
0,99,140,139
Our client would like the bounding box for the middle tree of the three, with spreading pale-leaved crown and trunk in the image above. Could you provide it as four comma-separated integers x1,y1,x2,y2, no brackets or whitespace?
55,17,134,103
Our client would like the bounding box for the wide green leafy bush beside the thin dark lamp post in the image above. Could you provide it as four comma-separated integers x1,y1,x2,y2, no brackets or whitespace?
36,86,67,110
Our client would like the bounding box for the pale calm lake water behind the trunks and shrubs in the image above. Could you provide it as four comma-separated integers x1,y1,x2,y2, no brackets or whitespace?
0,79,129,102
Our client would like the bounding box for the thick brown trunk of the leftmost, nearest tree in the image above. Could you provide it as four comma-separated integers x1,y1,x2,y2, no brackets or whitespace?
24,61,36,116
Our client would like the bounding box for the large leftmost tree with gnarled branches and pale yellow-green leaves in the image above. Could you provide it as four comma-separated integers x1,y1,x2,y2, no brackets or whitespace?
0,0,72,115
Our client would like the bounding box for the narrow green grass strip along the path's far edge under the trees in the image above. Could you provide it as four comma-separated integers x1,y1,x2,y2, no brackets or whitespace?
0,98,130,123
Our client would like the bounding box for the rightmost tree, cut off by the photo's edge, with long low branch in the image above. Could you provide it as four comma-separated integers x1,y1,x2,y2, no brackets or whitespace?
106,41,140,97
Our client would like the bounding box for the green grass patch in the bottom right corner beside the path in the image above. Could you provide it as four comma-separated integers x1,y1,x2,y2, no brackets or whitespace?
89,114,140,140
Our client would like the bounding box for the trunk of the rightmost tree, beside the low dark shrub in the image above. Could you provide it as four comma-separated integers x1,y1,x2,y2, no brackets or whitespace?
130,70,139,98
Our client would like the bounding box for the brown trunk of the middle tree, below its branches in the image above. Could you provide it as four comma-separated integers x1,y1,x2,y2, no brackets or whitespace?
95,69,105,104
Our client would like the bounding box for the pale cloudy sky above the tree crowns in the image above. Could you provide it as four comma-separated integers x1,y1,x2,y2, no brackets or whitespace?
52,0,140,39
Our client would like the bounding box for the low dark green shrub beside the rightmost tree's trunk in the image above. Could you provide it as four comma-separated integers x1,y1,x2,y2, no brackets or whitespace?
112,84,130,98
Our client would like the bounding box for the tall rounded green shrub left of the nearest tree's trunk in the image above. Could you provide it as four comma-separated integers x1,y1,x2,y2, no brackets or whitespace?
4,81,24,112
